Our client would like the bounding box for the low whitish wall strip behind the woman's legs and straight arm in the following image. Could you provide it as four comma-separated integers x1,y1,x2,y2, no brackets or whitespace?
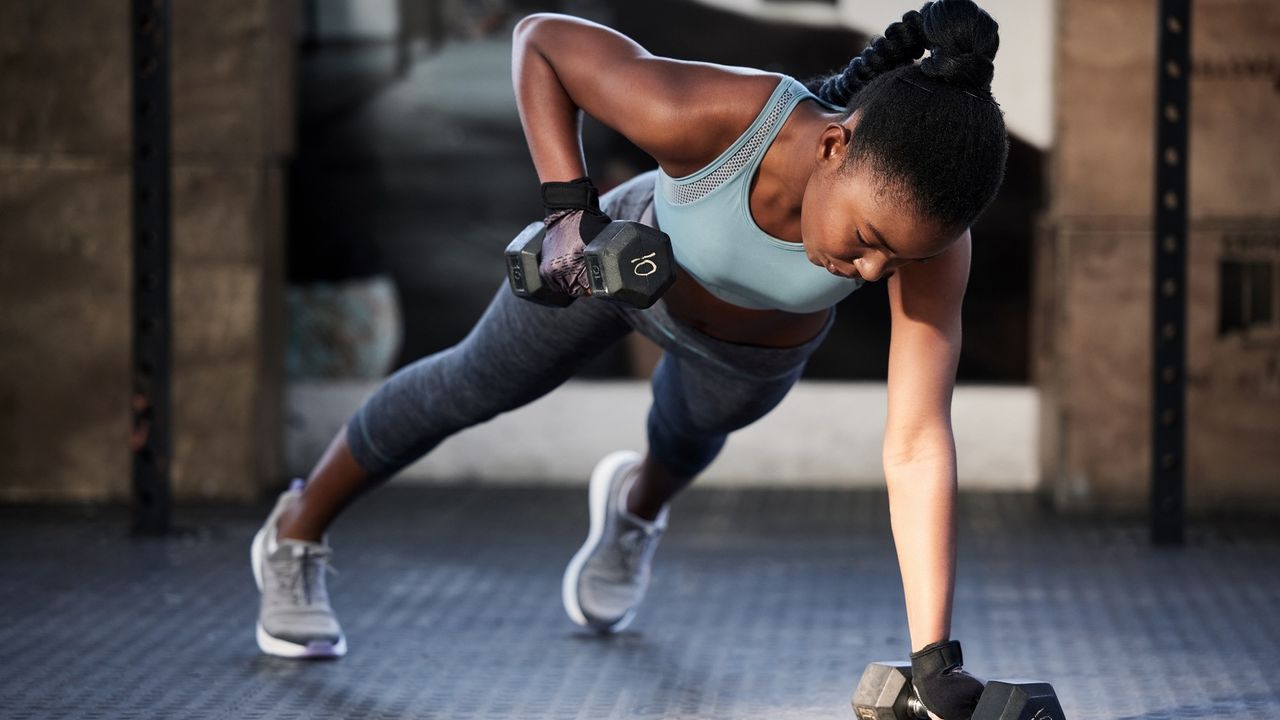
284,379,1038,491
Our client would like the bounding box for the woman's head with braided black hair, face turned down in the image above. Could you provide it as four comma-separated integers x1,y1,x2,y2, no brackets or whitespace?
804,0,1009,279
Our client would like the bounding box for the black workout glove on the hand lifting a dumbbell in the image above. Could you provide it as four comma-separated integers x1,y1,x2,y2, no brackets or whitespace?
538,177,611,297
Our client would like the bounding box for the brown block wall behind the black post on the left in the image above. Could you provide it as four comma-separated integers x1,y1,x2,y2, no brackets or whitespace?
0,0,293,500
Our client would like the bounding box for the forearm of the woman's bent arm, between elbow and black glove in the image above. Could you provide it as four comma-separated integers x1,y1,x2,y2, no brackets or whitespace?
511,14,586,182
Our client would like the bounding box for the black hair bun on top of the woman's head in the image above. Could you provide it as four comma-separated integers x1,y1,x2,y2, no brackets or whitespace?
920,0,1000,92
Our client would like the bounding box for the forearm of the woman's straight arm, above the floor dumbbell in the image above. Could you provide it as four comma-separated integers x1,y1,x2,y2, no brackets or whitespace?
884,450,956,652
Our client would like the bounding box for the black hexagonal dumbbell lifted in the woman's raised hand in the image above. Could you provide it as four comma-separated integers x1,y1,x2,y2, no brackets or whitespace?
507,220,676,307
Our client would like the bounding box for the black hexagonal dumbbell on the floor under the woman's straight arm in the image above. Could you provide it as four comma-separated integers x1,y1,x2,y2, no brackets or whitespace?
852,662,1065,720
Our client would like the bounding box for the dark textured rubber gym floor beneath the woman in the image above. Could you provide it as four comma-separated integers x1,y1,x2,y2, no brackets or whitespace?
0,484,1280,720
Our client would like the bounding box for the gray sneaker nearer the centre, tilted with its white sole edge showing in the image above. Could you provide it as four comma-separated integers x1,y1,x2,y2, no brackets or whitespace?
562,451,667,633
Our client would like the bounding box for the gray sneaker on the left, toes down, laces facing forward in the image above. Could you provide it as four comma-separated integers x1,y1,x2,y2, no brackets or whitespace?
250,480,347,657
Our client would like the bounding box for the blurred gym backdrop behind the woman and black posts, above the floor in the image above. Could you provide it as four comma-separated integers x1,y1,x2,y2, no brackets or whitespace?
0,0,1280,504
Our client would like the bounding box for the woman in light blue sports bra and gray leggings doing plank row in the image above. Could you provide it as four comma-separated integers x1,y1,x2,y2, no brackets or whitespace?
253,0,1007,719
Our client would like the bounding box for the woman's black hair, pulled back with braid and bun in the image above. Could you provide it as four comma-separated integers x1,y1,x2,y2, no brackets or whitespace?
808,0,1009,229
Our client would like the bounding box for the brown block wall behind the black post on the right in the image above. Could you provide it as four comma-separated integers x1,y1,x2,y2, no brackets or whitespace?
1034,0,1280,515
